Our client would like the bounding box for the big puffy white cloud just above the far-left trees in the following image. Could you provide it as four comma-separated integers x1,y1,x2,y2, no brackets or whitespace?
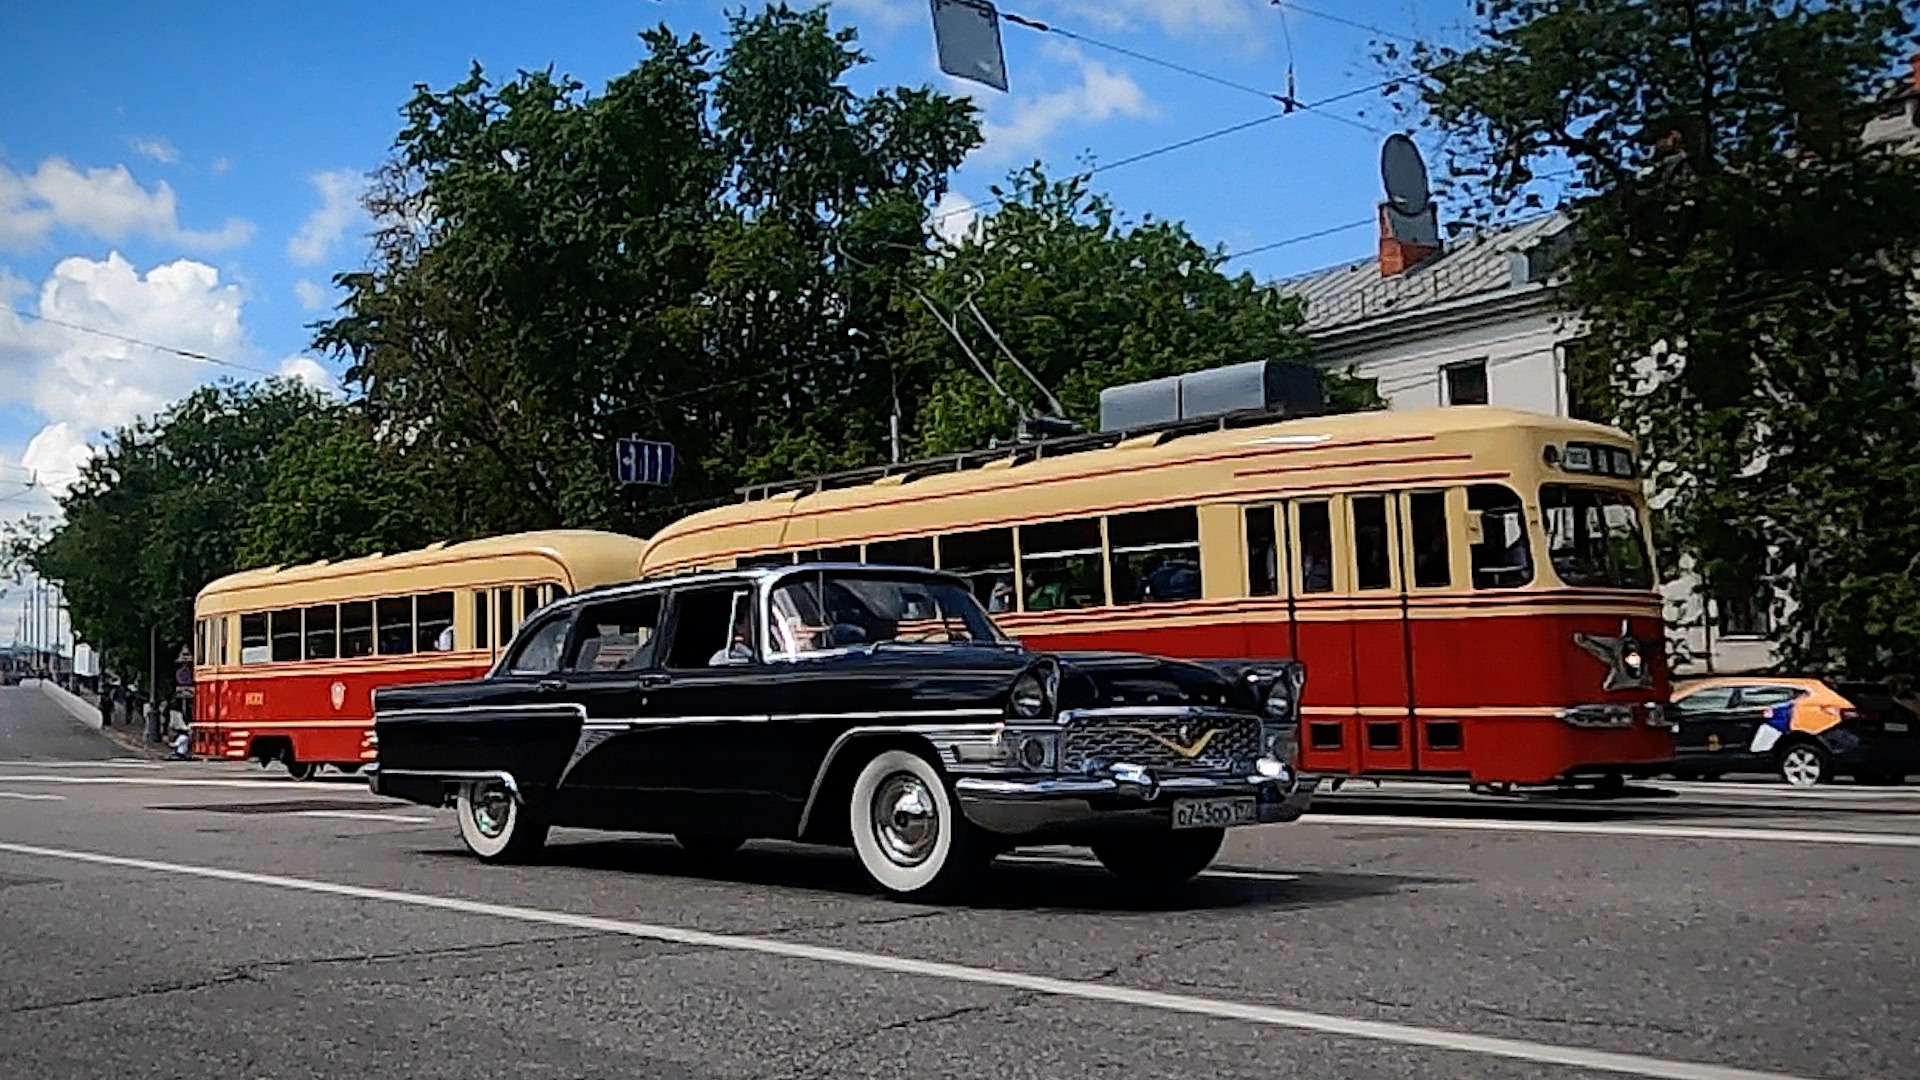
0,252,246,445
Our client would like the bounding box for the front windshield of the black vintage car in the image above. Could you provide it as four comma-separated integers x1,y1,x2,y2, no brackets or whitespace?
768,571,1008,655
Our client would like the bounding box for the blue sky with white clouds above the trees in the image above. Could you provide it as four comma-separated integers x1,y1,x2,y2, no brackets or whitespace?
0,0,1467,640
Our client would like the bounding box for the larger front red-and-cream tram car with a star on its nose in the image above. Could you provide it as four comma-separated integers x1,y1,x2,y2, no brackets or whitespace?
639,405,1672,784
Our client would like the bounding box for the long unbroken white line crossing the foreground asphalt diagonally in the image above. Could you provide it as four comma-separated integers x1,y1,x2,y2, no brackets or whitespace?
0,842,1827,1080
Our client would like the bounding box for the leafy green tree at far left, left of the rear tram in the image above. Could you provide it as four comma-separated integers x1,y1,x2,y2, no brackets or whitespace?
21,380,330,686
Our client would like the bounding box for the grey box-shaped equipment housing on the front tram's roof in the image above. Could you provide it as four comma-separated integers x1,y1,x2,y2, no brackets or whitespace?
1100,359,1327,430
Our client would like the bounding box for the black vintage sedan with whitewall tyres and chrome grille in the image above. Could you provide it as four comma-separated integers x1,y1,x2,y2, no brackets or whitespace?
371,563,1315,896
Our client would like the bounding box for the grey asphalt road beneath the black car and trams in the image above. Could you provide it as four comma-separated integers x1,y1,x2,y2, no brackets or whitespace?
0,690,1920,1080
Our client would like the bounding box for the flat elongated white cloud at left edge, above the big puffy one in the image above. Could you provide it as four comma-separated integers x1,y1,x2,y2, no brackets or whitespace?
0,158,253,250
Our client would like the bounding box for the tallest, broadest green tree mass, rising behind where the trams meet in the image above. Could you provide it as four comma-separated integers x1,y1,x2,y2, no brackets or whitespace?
317,6,979,530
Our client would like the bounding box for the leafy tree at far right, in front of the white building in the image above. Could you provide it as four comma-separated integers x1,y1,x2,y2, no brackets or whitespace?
1388,0,1920,673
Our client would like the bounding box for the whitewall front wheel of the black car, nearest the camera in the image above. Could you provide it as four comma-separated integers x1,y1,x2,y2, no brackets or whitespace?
847,749,987,899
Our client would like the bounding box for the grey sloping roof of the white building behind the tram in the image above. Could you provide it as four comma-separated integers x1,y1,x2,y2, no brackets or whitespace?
1273,211,1569,334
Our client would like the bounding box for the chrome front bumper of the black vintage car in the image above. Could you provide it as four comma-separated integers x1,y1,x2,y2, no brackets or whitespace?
954,757,1319,840
